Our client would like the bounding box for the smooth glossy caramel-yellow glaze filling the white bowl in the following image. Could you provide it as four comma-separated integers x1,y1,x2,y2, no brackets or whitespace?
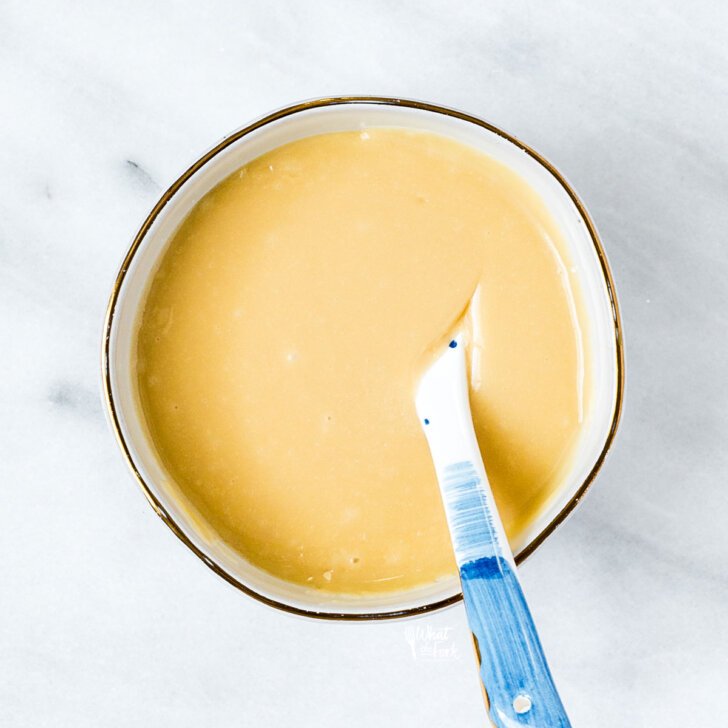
136,128,589,593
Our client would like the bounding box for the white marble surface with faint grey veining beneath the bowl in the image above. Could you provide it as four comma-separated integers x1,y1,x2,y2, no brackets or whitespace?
0,0,728,728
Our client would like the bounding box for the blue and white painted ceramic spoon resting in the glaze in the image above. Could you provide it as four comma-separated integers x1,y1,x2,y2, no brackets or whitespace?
416,337,571,728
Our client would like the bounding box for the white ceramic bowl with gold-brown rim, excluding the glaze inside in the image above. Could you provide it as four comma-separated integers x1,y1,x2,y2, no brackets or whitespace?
102,97,623,619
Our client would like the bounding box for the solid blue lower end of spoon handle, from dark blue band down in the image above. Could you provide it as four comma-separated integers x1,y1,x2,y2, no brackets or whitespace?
460,556,571,728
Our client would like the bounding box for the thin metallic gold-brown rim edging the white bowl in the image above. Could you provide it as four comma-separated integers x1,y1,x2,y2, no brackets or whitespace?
101,96,624,621
